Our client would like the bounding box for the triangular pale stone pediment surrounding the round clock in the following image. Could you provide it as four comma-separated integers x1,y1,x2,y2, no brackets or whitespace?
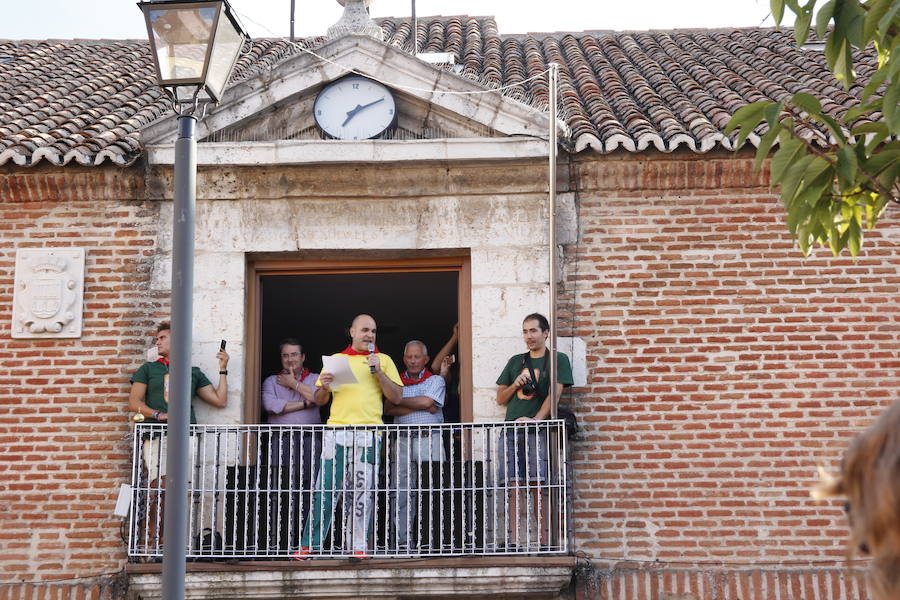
143,35,549,157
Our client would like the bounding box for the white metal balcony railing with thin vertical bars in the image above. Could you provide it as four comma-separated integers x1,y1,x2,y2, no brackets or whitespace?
128,421,568,560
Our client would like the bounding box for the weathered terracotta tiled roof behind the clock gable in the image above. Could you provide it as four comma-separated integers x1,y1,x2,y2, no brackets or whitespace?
0,16,875,165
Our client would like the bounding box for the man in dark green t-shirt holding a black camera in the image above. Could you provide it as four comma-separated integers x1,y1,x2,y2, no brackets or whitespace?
497,313,573,550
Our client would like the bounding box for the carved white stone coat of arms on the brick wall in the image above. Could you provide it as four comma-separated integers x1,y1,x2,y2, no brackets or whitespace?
12,248,84,338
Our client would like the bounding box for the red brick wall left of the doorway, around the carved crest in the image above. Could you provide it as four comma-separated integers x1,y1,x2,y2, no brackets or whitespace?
0,168,168,584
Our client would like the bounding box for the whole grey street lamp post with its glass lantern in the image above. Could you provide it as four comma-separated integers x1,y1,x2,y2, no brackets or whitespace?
138,0,248,600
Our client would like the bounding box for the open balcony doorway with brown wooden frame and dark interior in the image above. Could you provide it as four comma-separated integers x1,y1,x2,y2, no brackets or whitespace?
245,256,472,423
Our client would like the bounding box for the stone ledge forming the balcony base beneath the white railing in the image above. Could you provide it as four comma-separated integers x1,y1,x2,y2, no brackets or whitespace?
126,556,575,600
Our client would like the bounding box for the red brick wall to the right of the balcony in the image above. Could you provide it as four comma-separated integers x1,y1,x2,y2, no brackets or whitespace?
560,150,900,572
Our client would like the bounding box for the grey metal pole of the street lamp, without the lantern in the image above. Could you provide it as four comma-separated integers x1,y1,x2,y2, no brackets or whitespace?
162,114,197,600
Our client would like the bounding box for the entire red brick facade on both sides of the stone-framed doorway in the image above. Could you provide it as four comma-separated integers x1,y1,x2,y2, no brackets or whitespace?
0,153,900,600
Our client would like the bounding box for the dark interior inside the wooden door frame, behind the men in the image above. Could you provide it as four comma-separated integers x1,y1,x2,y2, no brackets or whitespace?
260,271,459,422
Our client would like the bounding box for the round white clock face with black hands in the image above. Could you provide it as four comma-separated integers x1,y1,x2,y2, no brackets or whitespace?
313,75,397,140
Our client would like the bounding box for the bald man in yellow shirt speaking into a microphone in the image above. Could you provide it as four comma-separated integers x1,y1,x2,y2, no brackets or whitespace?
294,315,403,559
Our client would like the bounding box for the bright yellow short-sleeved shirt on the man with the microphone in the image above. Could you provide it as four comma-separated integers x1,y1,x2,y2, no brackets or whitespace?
316,352,403,425
